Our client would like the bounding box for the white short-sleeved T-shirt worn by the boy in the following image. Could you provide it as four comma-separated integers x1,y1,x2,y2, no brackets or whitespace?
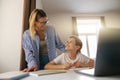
53,53,90,68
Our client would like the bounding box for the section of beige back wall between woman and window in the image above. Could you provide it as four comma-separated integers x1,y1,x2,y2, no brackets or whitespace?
48,13,72,42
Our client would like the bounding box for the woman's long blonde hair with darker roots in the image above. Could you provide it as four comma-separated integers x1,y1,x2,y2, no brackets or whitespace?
29,9,47,39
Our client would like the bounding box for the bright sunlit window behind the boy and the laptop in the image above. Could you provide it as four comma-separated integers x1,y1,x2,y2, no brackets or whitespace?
76,17,102,58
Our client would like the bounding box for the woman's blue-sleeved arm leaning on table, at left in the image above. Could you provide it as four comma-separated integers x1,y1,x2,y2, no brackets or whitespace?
22,30,38,69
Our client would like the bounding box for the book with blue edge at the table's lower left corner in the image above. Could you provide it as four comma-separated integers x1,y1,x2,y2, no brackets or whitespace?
0,71,29,80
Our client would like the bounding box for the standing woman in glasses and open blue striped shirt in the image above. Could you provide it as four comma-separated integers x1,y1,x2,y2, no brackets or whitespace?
22,9,65,72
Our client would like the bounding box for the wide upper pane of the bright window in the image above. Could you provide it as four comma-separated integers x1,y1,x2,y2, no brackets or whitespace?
77,19,101,34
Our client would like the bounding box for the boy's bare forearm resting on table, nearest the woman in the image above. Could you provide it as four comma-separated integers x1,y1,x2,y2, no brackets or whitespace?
44,61,72,70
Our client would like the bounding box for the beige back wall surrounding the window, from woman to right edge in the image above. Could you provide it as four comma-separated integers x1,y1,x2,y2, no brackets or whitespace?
48,12,120,42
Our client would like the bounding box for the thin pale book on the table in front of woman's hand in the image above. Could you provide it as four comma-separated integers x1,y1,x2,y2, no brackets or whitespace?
29,70,67,76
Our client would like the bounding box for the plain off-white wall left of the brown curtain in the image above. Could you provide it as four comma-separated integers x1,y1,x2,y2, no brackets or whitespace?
0,0,23,73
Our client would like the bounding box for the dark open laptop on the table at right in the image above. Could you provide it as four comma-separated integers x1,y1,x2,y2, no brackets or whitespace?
75,28,120,76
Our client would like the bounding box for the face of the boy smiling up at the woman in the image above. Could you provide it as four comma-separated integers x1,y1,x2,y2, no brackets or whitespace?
65,38,78,51
